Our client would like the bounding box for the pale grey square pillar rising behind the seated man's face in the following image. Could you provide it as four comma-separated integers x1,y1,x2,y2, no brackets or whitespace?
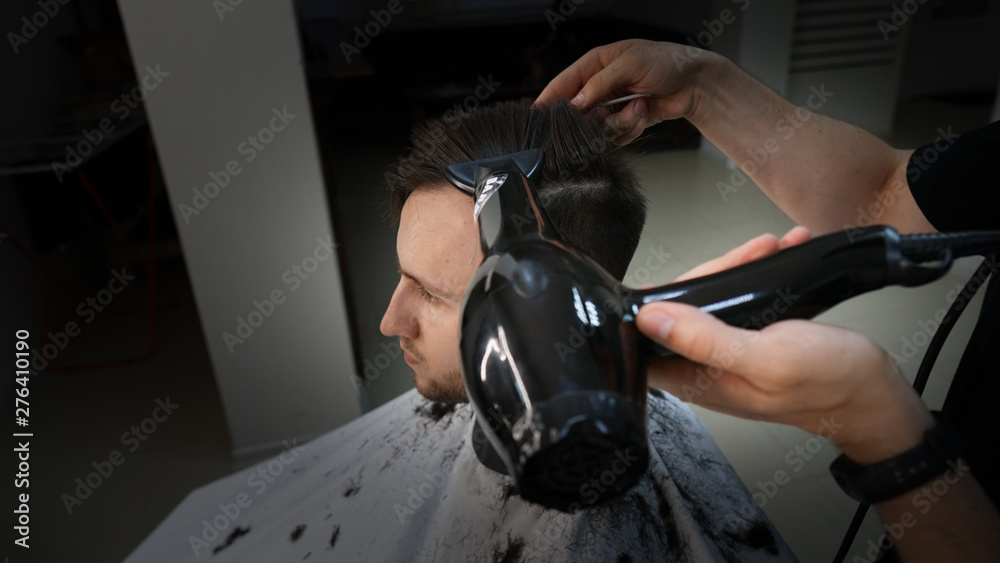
119,0,360,454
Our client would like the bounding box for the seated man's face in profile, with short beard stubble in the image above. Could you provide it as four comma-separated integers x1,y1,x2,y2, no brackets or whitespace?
379,185,483,402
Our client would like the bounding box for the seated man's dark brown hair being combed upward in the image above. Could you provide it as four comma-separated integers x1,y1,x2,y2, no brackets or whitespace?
385,99,647,280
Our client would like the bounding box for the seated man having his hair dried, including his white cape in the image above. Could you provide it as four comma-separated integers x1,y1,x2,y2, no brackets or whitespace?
123,100,807,563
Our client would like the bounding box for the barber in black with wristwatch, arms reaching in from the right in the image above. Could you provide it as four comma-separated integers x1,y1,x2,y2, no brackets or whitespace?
537,40,1000,561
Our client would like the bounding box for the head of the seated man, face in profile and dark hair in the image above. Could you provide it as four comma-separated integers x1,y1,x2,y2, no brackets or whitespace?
381,100,646,402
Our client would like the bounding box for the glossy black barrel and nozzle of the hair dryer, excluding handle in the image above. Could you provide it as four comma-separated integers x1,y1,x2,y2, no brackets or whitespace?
460,156,648,511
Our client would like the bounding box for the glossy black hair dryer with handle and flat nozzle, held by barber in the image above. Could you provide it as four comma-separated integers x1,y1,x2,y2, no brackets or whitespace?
445,150,1000,512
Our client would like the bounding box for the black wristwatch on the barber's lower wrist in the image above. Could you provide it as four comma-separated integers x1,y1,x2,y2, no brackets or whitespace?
830,411,962,504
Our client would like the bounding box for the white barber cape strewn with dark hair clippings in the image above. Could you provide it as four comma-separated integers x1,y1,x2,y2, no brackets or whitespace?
126,391,795,563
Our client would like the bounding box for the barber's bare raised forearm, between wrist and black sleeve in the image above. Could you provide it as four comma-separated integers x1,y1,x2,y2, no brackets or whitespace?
688,53,932,233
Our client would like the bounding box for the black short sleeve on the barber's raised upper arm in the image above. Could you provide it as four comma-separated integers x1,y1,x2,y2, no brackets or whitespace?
906,121,1000,232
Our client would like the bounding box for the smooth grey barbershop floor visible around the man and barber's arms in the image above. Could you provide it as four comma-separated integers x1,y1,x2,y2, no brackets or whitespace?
35,98,988,562
